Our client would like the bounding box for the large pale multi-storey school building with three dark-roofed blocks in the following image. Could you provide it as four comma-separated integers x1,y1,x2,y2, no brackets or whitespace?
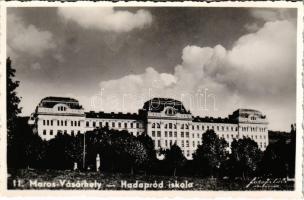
29,97,268,159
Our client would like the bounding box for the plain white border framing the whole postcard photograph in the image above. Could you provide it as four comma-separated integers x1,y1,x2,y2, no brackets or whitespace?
0,1,303,198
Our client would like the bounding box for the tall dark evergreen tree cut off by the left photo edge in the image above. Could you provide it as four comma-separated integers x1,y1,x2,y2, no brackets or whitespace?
6,57,21,167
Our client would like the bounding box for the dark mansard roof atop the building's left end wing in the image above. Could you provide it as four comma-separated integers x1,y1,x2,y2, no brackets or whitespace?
39,96,82,109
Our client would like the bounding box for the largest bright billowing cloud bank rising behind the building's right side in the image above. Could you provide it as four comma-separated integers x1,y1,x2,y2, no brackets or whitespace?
87,16,296,130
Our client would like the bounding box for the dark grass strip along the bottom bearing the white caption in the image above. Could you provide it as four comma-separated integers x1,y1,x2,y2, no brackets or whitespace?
8,170,294,190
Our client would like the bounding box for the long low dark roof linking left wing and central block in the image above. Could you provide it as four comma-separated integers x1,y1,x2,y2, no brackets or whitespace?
85,111,142,120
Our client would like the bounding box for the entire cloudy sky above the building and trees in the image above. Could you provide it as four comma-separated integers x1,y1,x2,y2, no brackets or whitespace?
7,7,297,131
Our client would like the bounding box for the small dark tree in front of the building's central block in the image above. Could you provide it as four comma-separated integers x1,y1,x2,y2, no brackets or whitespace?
164,144,186,176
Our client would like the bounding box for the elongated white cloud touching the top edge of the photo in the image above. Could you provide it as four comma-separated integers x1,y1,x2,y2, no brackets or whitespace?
58,7,152,32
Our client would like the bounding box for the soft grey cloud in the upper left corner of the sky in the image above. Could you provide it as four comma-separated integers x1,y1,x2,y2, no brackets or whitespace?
7,13,56,57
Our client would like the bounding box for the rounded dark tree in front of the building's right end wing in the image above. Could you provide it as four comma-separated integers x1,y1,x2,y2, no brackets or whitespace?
230,138,262,178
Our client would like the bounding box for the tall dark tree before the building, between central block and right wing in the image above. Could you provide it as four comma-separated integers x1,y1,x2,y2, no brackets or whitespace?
193,130,228,176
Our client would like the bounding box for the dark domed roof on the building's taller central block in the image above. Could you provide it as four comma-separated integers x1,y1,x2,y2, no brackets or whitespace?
143,97,190,114
